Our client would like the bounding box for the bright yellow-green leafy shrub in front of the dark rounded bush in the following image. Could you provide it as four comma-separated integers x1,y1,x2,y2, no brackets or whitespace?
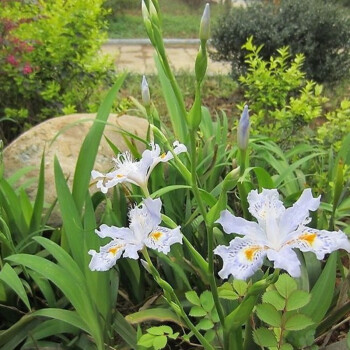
239,38,327,148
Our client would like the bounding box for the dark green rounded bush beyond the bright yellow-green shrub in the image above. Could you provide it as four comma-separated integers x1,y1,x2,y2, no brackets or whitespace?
212,0,350,82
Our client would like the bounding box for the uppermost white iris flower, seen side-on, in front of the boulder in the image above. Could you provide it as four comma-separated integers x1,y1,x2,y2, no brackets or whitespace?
91,141,187,193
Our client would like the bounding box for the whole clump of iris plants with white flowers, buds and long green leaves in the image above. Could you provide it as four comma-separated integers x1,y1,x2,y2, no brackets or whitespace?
0,0,350,350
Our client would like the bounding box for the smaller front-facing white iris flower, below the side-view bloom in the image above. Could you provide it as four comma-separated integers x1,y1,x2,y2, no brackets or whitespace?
89,198,182,271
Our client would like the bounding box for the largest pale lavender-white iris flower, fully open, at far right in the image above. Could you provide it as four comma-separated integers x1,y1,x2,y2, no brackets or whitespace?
214,189,350,279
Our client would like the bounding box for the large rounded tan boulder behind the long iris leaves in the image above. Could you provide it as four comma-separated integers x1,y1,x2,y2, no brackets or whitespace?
3,114,148,225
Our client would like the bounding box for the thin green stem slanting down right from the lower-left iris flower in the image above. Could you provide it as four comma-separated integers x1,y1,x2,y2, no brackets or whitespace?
142,247,215,350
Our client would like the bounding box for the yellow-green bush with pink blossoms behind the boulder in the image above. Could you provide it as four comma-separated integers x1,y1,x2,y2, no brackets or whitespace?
0,0,114,141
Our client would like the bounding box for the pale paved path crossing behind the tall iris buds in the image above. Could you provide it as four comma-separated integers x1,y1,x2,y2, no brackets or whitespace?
102,39,230,75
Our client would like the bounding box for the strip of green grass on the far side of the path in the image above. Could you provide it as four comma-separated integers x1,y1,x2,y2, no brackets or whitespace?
109,0,224,38
